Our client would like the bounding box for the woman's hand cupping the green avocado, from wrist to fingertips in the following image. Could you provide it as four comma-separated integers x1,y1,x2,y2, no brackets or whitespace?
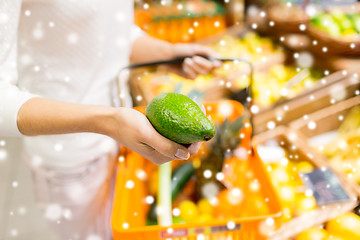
109,108,201,165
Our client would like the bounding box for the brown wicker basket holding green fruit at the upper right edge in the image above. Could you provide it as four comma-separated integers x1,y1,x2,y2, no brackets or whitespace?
308,25,360,57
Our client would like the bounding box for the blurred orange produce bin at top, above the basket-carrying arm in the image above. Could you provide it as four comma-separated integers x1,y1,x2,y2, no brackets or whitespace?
135,1,226,43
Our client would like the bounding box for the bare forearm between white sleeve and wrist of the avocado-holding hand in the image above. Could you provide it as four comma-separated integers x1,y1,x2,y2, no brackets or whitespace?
17,98,115,136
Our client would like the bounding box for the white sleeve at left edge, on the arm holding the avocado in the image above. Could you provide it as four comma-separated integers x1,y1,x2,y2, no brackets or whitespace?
0,0,35,136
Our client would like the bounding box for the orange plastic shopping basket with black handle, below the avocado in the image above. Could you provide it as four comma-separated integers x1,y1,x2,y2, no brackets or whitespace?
111,100,282,240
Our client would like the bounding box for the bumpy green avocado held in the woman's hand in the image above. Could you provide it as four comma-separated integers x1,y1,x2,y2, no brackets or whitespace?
145,93,215,144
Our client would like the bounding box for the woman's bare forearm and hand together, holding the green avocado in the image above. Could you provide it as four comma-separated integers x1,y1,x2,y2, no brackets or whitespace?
17,97,201,164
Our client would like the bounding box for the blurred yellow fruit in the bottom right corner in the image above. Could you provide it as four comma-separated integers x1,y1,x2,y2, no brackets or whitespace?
326,212,360,239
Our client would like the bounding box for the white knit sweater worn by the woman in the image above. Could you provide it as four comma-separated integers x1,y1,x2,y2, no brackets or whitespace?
0,0,141,167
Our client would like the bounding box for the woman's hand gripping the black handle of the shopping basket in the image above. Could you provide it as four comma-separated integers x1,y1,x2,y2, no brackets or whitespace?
173,43,222,79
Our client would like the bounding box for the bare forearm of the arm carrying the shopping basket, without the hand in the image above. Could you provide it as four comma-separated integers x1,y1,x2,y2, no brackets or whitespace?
130,35,175,63
